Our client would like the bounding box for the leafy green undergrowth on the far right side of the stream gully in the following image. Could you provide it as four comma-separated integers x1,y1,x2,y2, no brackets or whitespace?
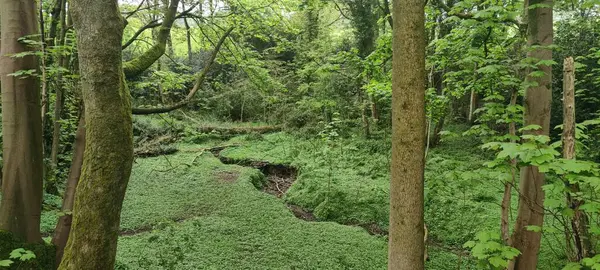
221,126,562,269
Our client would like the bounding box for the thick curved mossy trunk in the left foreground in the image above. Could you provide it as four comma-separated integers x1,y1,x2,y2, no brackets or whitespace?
59,0,133,269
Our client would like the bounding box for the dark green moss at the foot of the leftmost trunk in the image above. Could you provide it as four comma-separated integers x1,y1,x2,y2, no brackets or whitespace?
0,231,56,270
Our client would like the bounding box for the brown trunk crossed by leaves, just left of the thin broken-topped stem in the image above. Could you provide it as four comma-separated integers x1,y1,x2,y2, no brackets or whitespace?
511,0,553,270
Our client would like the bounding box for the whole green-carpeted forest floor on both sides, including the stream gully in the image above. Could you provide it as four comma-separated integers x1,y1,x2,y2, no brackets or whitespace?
42,115,558,269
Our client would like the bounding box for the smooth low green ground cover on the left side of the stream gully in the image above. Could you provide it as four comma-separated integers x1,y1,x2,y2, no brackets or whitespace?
117,151,387,269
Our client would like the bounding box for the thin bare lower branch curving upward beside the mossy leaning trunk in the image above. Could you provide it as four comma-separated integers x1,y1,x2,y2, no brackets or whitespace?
132,27,234,115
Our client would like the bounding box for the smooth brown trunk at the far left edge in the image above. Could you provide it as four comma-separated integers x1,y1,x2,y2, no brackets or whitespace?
0,0,44,242
